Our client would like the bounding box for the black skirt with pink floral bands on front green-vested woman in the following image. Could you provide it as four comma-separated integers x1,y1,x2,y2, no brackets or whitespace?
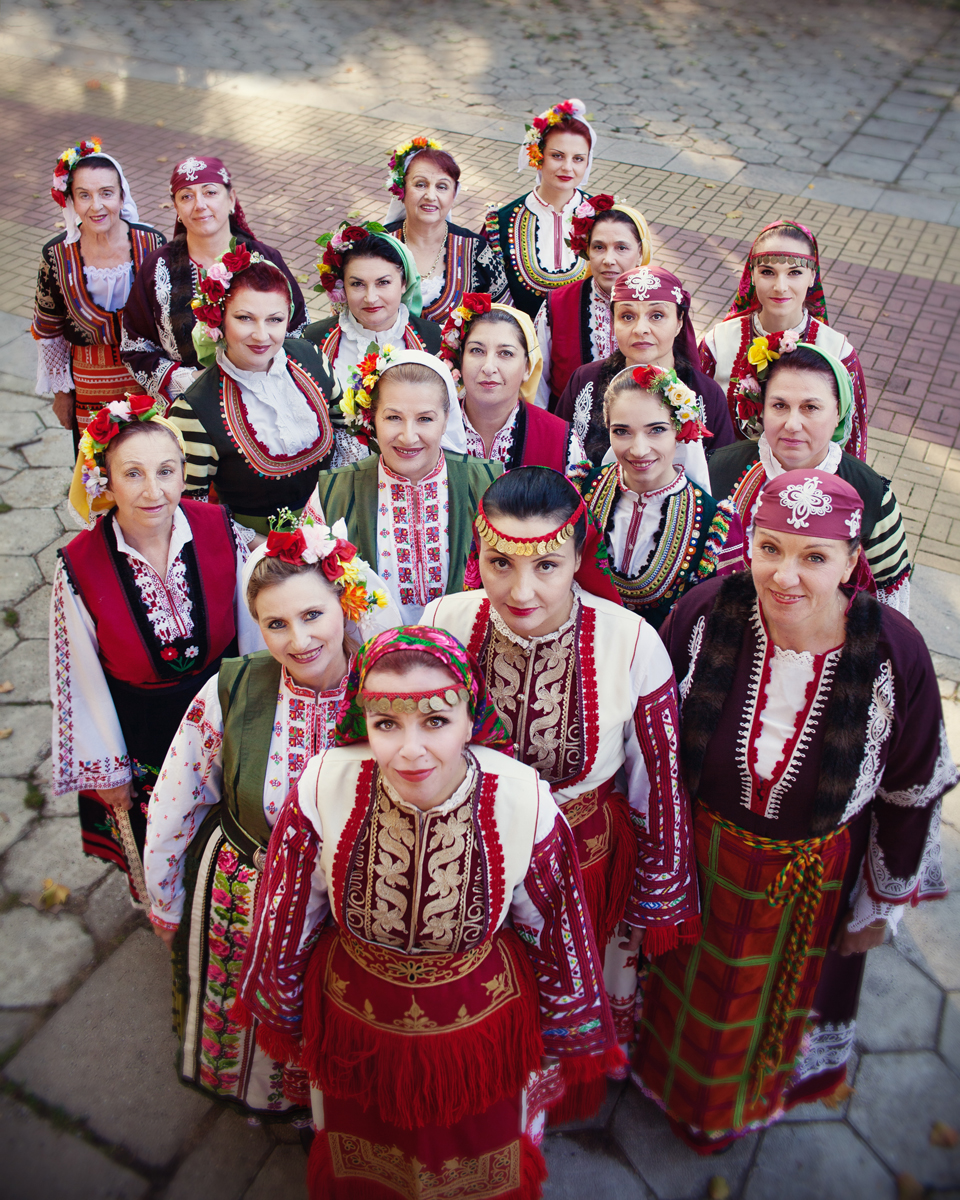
173,814,310,1121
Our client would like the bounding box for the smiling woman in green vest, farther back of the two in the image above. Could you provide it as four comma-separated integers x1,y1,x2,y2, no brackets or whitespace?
306,348,503,624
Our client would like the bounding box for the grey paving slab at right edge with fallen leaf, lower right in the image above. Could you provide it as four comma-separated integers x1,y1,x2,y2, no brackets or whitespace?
848,1051,960,1187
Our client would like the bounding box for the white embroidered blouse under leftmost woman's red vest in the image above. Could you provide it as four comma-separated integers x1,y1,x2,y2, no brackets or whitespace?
49,509,264,796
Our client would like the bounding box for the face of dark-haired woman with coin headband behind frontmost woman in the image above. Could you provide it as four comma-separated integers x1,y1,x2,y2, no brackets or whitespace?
480,512,580,637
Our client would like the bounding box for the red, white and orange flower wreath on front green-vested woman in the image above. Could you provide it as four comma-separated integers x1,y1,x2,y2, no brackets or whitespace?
263,509,388,622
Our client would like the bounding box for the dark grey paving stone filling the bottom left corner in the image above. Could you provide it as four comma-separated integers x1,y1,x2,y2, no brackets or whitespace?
0,1097,150,1200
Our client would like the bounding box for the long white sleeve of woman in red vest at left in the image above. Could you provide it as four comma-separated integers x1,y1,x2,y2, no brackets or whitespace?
49,563,133,796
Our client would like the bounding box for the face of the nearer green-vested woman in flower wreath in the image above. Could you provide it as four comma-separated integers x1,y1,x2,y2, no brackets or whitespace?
256,570,347,691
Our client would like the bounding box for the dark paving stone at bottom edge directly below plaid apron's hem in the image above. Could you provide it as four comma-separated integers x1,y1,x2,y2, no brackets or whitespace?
610,1086,757,1200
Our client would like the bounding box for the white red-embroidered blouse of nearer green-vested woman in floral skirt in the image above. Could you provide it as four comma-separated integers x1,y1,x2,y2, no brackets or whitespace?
143,667,346,928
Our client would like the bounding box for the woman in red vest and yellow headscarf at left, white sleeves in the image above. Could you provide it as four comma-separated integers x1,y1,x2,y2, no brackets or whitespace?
50,395,262,905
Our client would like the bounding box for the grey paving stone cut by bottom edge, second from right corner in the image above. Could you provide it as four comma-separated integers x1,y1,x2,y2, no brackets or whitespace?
744,1123,896,1200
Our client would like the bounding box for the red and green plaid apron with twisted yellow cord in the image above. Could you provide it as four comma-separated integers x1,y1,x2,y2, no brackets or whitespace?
634,806,850,1140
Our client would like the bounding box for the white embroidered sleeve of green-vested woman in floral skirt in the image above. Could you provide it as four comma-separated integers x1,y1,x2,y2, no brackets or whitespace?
143,676,223,929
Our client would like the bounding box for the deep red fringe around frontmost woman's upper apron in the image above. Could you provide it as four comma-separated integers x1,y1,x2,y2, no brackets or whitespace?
300,940,544,1129
